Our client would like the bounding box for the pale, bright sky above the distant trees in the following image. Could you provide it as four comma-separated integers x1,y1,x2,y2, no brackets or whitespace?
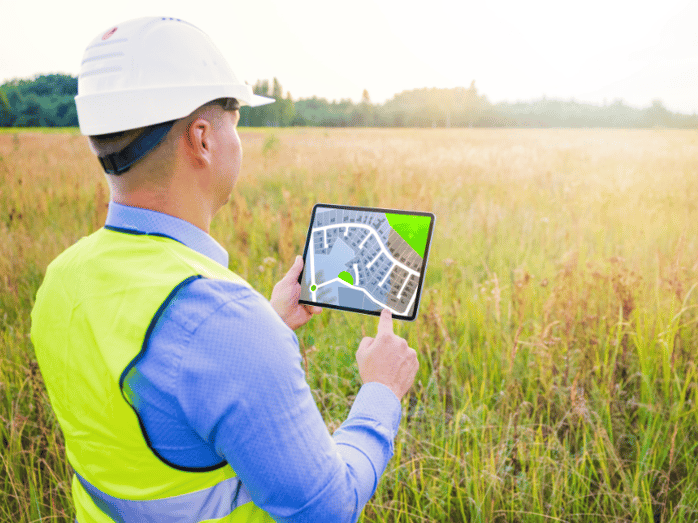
0,0,698,113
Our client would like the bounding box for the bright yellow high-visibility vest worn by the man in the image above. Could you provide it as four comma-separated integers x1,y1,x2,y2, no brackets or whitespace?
31,229,273,523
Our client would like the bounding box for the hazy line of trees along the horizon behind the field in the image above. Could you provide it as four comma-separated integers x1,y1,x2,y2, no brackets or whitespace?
0,74,698,128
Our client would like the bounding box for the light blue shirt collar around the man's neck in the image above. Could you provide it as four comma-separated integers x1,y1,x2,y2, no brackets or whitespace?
105,201,228,267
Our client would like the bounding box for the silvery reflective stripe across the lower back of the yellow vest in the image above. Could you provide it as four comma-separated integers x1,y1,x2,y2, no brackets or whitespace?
76,474,252,523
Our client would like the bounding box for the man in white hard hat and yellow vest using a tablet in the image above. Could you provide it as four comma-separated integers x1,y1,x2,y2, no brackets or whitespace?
32,18,418,523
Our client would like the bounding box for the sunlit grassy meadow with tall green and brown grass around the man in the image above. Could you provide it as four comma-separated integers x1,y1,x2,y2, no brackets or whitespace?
0,129,698,523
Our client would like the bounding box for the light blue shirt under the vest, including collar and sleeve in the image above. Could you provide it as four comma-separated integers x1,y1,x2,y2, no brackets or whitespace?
106,202,401,522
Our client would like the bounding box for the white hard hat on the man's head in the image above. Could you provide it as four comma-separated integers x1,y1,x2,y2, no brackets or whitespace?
75,17,274,136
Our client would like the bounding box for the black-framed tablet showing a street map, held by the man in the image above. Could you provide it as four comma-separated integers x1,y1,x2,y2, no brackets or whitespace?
298,203,435,321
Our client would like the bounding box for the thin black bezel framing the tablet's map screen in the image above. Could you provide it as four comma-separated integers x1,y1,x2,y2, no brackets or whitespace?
298,203,436,321
